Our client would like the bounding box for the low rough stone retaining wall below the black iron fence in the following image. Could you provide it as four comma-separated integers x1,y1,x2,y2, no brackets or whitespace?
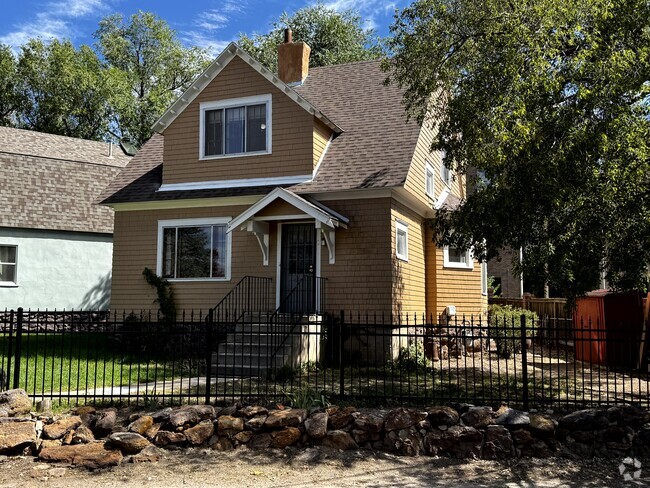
0,390,650,468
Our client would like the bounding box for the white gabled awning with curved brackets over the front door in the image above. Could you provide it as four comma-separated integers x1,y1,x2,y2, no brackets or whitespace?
227,187,349,266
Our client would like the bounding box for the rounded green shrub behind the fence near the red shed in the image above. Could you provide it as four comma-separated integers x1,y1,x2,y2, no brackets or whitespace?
488,305,539,359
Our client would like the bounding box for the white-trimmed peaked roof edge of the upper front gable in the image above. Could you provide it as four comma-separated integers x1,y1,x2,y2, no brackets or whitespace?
153,42,343,133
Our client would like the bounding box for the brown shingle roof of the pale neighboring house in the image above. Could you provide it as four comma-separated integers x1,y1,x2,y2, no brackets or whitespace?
0,127,131,233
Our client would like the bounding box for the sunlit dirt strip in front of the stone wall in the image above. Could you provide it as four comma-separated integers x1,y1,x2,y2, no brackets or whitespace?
0,448,636,488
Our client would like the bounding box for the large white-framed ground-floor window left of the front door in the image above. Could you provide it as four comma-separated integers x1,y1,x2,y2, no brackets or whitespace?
158,219,230,279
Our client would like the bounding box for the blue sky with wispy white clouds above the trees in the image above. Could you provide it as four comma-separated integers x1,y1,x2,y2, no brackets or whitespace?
0,0,409,54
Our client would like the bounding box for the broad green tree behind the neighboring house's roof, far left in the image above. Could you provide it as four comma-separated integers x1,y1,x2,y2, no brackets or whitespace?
14,39,112,140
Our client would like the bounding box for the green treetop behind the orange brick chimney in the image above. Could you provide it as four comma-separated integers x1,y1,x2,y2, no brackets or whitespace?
238,3,383,72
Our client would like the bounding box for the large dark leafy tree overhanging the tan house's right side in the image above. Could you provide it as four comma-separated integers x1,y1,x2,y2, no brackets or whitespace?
385,0,650,298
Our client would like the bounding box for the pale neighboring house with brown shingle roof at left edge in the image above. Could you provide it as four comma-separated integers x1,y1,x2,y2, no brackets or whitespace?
0,127,130,310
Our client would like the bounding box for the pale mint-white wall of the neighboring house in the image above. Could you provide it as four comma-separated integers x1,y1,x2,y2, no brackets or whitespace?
0,228,113,310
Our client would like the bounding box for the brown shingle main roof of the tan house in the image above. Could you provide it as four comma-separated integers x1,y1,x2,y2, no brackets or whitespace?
101,61,420,204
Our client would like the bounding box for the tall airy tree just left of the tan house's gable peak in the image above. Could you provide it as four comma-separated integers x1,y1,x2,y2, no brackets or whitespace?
95,11,207,144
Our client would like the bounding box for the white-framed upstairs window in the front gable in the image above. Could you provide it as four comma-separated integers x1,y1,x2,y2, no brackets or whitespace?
200,95,271,159
